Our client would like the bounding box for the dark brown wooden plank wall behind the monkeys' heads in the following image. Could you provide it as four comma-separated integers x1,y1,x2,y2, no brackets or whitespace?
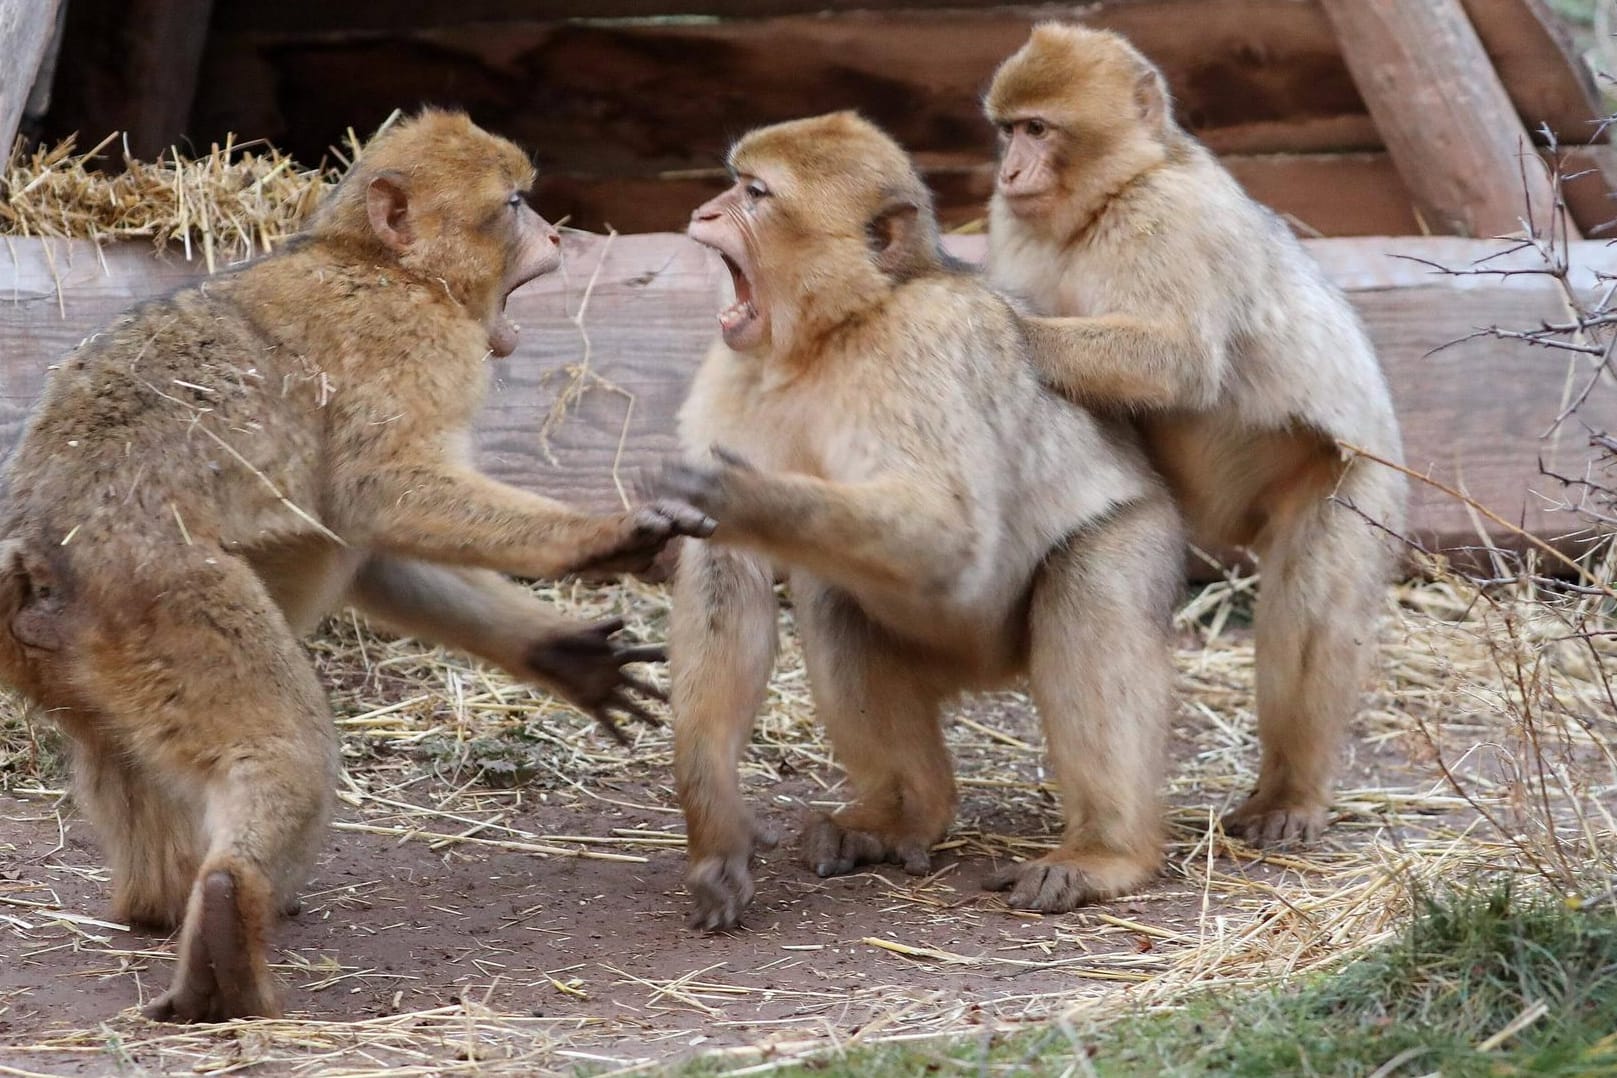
37,0,1617,236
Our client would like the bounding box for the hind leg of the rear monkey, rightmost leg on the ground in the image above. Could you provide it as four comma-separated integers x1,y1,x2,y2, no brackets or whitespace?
1222,462,1402,845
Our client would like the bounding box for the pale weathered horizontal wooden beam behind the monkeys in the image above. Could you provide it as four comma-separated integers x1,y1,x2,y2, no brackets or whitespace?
0,234,1617,562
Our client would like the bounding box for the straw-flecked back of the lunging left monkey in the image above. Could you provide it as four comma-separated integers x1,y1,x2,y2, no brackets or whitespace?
0,270,331,546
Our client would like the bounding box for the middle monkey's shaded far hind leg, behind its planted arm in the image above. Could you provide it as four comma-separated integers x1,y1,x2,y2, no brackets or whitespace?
792,579,956,876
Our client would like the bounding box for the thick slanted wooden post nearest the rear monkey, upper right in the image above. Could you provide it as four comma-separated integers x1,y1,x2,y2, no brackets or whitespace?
1321,0,1575,236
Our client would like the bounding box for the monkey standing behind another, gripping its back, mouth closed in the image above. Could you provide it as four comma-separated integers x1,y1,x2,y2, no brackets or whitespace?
986,24,1405,844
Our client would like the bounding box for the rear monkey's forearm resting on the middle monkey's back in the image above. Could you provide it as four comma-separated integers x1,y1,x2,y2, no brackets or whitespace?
1025,315,1222,409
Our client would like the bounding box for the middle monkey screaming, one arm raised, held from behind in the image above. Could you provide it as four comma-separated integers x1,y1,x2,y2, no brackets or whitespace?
666,113,1182,929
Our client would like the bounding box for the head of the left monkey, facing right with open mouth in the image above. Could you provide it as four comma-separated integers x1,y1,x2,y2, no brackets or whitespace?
310,108,561,356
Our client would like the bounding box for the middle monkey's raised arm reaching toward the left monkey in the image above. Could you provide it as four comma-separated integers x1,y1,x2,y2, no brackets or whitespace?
663,449,973,593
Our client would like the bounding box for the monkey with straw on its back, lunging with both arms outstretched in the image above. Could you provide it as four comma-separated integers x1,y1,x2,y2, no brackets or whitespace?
0,112,711,1020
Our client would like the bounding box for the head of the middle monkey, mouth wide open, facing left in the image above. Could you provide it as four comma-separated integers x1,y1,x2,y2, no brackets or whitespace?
687,112,941,352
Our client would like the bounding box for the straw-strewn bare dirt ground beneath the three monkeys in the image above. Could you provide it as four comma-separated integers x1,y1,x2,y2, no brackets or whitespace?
0,581,1591,1076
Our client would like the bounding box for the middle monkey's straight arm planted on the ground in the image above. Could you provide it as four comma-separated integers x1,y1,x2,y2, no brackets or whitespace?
668,541,778,931
